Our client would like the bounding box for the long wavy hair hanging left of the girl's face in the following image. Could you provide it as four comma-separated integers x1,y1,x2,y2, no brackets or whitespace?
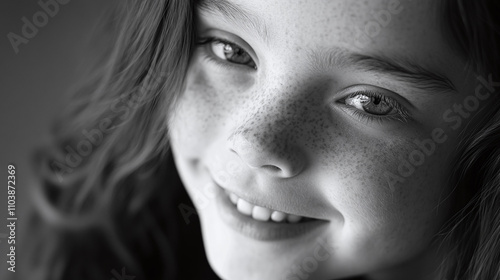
20,0,207,280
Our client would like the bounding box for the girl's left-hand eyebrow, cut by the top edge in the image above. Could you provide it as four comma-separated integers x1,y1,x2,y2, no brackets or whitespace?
197,0,270,43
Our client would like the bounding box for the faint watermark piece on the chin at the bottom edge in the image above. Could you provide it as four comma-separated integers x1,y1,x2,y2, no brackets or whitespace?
282,238,335,280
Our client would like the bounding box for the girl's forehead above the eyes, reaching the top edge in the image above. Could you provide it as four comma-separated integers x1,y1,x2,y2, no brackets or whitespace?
196,0,463,80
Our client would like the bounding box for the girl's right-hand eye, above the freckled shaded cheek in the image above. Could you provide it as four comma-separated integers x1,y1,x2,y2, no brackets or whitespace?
341,91,409,122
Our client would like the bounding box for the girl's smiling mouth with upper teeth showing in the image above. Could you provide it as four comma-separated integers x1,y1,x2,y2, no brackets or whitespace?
215,183,329,241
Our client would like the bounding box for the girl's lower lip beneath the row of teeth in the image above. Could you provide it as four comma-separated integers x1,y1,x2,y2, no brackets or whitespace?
216,186,328,241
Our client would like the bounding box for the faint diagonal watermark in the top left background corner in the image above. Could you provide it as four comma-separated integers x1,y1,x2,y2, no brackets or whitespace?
7,0,70,54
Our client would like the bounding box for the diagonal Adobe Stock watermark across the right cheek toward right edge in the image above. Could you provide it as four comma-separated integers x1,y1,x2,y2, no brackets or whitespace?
384,74,500,191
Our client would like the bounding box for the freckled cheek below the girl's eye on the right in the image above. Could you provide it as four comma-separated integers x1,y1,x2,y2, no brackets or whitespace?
318,122,458,255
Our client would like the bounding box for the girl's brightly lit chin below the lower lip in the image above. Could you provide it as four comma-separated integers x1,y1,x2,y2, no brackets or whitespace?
199,198,338,280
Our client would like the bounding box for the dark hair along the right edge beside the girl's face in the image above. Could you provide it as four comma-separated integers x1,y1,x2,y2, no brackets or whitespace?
440,0,500,280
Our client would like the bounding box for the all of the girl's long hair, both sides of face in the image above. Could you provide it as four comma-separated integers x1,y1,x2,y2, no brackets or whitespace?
21,0,500,280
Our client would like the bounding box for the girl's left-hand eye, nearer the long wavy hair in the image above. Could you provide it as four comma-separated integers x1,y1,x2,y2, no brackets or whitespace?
198,37,257,69
